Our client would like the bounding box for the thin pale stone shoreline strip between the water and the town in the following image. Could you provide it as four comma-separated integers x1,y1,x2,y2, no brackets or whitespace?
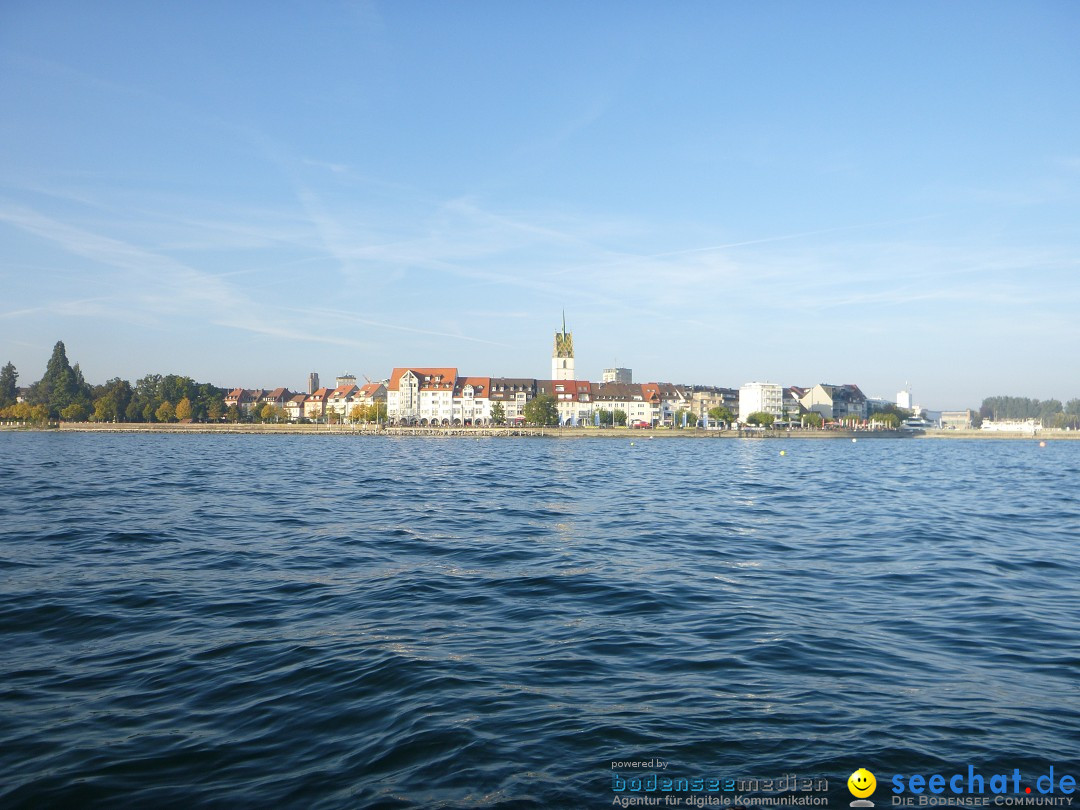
0,422,1080,442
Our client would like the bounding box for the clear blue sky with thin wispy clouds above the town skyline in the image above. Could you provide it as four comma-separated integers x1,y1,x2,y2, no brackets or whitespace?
0,0,1080,408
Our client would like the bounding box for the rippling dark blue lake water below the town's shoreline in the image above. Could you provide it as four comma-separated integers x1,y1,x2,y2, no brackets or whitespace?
0,433,1080,808
